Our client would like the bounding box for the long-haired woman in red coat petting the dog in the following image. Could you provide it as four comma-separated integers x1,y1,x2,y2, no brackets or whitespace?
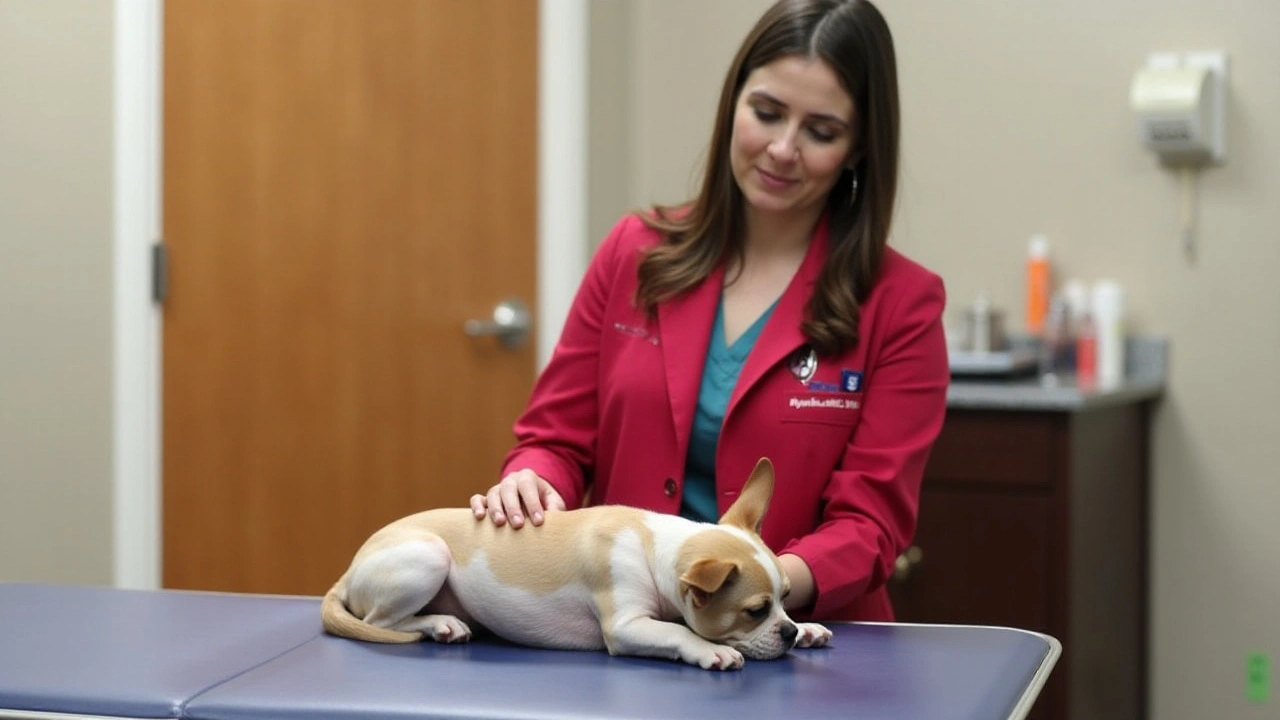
471,0,948,620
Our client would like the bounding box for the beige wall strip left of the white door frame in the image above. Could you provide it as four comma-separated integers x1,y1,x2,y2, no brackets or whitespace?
0,0,114,583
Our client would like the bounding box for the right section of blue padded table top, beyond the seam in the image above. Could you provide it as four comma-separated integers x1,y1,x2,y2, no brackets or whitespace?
187,624,1060,720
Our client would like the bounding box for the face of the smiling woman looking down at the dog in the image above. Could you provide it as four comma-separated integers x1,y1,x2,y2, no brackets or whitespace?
730,55,854,221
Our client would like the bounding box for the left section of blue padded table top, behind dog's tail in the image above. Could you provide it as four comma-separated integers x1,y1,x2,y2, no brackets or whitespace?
0,583,321,717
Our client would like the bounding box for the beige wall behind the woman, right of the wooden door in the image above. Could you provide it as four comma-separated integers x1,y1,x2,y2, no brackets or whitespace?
593,0,1280,720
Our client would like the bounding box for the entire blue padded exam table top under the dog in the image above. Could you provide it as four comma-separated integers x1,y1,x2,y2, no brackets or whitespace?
0,583,1060,720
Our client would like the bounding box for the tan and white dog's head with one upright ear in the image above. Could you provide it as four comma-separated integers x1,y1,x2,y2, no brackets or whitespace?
677,457,797,660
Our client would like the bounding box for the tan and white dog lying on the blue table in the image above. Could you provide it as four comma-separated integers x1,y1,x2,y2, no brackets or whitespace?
321,459,831,670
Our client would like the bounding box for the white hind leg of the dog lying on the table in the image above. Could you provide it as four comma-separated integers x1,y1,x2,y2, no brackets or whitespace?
348,533,471,642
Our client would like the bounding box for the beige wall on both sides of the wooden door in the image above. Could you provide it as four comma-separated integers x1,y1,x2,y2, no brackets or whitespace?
0,0,1280,720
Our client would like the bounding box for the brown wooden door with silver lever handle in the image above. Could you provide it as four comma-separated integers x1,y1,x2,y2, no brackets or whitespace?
163,0,538,594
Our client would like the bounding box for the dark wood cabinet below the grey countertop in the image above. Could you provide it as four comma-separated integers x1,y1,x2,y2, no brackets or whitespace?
890,401,1152,720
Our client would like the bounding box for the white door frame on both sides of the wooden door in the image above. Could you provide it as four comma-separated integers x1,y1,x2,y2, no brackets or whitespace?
111,0,590,589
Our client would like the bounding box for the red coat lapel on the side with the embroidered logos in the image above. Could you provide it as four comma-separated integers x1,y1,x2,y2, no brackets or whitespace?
724,218,828,412
